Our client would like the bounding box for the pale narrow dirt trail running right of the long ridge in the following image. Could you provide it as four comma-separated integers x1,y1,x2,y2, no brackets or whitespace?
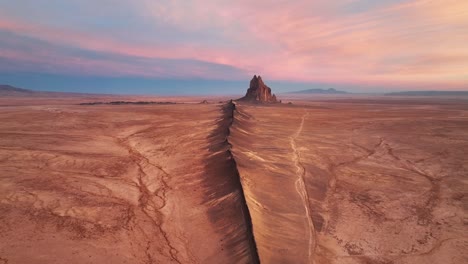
290,112,315,263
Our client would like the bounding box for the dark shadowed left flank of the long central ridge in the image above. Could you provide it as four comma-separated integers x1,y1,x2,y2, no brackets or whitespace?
202,101,260,263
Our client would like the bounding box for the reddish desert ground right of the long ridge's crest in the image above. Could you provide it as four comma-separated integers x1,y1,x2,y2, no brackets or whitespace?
231,99,468,264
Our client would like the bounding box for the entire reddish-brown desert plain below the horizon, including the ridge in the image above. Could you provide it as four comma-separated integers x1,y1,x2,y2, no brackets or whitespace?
0,98,468,264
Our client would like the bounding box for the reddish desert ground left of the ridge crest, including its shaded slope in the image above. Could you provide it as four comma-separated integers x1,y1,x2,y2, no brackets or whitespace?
0,101,252,264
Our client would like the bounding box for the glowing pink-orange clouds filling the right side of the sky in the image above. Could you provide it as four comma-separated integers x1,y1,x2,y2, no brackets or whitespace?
0,0,468,87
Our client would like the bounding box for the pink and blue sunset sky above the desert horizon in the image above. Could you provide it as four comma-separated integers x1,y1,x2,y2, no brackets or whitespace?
0,0,468,94
